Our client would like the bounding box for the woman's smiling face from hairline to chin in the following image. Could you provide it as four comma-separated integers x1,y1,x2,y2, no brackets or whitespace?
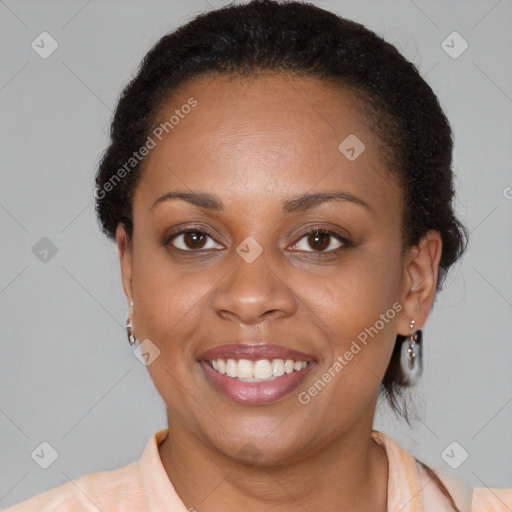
118,73,436,462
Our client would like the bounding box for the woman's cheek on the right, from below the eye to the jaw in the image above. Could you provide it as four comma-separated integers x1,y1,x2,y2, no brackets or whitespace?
288,248,402,440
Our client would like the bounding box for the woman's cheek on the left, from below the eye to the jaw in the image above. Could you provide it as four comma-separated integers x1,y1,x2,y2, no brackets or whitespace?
133,244,216,425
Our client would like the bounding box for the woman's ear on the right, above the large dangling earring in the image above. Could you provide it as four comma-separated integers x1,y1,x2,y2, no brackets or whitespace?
397,230,443,336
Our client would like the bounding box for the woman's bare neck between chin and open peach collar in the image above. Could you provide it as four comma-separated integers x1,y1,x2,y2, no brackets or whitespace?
159,413,388,512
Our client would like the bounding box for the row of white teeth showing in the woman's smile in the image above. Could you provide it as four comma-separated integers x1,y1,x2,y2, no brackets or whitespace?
211,359,307,382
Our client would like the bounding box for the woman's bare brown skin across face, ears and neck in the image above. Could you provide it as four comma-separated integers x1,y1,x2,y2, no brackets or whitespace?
116,73,441,512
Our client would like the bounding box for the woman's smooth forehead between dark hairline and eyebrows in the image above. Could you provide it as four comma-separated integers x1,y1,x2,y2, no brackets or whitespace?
132,73,400,214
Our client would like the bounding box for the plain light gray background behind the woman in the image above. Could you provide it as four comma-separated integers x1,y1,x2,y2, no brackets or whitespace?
0,0,512,507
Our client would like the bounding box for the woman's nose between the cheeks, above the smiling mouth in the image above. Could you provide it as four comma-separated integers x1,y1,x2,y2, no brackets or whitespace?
213,250,297,326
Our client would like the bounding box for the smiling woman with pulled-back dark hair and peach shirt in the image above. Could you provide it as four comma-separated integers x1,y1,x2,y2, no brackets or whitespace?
5,0,512,512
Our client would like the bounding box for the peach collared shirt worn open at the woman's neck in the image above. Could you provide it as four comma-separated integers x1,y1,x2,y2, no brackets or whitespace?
4,427,512,512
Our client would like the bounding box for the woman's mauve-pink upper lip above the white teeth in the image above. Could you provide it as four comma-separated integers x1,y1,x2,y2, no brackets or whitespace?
198,341,315,361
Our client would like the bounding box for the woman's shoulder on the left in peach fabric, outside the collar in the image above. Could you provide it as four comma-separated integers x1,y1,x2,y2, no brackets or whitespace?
4,463,139,512
